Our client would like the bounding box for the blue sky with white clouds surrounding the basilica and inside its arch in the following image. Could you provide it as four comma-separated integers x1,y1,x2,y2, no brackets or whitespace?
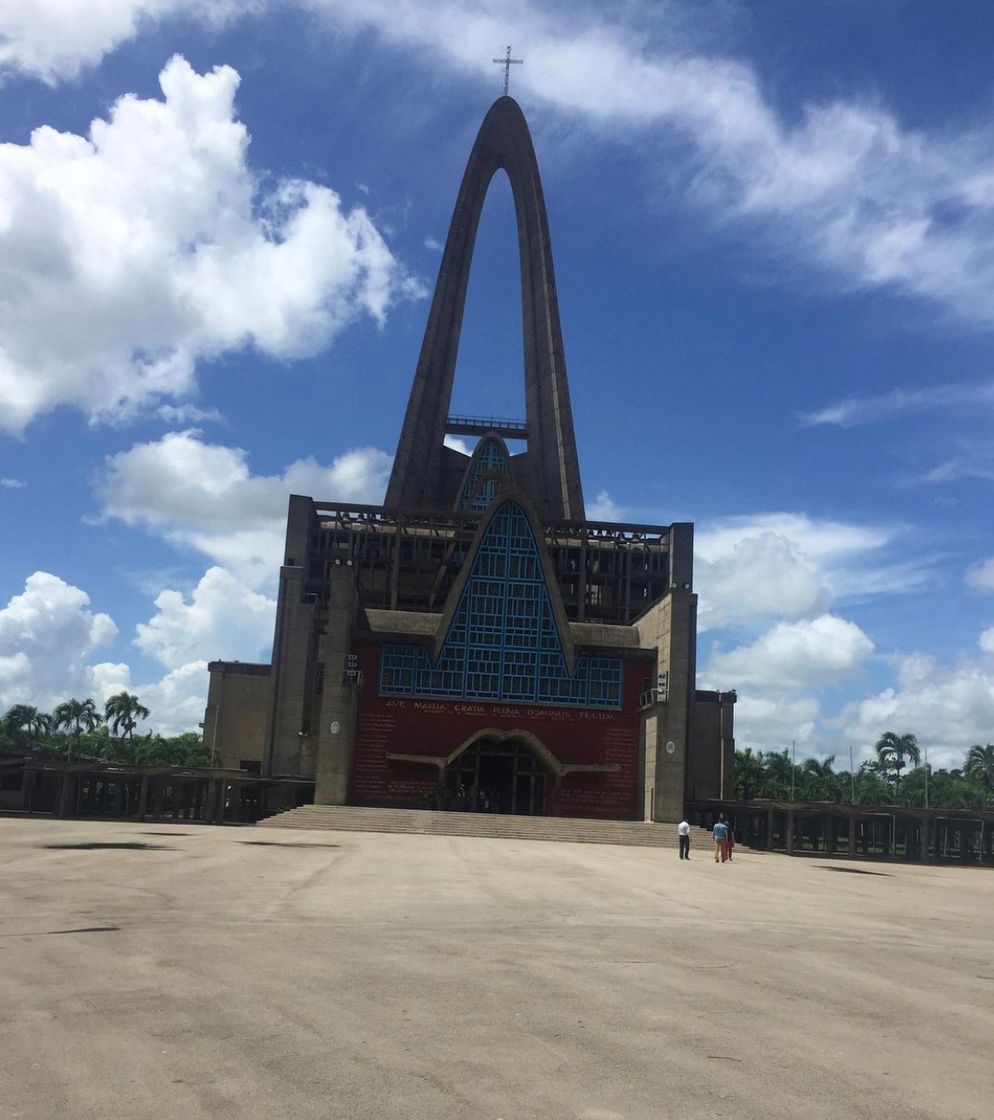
0,0,994,762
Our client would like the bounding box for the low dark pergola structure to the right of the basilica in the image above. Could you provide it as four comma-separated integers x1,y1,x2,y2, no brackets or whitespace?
687,800,994,866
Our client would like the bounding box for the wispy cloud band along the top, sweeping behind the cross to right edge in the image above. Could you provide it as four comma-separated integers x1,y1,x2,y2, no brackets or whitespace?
7,0,994,326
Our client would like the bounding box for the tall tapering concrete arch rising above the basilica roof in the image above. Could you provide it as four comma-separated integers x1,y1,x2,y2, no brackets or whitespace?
386,97,584,521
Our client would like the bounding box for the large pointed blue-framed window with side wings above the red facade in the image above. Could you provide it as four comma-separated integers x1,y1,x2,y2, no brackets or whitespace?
379,502,622,708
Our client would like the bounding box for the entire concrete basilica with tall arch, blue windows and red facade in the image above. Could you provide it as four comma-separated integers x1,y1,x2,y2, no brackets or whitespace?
204,96,735,821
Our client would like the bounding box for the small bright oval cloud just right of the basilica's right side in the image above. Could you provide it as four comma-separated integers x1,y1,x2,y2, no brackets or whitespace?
707,615,873,690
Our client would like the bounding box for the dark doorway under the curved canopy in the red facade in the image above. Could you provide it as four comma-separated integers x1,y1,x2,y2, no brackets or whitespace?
446,739,545,816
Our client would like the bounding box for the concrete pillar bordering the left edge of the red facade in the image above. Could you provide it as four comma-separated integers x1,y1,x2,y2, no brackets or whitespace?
311,566,360,805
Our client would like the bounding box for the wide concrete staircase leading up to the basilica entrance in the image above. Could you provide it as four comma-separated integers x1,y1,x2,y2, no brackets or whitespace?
257,805,697,851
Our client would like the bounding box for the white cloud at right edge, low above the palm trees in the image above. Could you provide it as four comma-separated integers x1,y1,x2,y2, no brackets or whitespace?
843,645,994,766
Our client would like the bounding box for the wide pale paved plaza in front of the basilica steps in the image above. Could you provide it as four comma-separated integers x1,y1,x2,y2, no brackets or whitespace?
0,818,994,1120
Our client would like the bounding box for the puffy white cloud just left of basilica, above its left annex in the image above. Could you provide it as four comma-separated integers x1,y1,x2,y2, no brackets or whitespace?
134,568,276,670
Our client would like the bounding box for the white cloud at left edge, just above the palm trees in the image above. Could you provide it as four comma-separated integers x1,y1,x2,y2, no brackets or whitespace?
0,571,118,709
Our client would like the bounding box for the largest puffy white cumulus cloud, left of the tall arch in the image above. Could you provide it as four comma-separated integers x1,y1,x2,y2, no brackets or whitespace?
0,55,418,432
